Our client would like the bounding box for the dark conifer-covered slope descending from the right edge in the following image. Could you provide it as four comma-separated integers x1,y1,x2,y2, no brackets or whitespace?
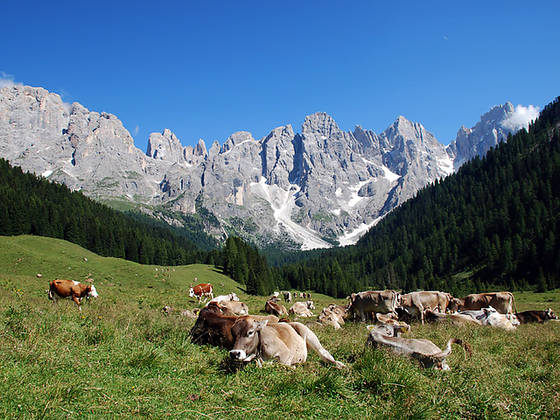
279,99,560,296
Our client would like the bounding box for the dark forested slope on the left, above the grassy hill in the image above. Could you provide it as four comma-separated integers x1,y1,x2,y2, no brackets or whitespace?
0,159,214,265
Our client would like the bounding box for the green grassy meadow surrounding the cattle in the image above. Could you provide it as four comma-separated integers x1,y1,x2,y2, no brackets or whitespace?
0,236,560,419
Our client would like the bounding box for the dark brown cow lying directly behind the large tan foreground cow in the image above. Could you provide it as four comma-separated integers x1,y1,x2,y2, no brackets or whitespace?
190,304,278,350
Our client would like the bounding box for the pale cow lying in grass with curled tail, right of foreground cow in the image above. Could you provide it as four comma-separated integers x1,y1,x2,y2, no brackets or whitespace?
367,323,471,370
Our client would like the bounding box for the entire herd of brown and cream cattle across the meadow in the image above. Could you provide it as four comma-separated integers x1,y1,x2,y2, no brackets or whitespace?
48,280,558,370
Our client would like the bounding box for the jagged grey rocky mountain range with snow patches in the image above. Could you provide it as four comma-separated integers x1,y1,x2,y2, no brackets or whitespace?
0,85,532,249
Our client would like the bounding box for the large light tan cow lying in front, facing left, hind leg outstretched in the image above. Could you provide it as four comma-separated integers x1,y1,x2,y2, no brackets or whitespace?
229,318,346,369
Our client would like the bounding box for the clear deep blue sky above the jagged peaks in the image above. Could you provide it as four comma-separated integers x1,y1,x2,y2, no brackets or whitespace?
0,0,560,150
